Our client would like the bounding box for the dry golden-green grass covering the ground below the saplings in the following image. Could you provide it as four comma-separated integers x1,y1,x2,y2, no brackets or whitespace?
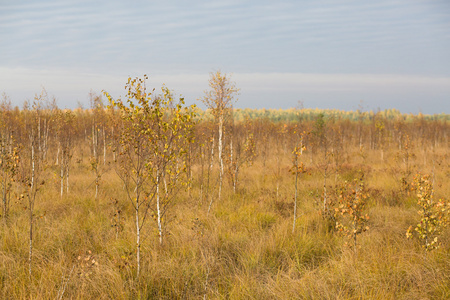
0,138,450,299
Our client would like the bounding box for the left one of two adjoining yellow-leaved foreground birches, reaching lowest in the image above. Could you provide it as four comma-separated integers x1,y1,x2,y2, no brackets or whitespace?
103,76,152,279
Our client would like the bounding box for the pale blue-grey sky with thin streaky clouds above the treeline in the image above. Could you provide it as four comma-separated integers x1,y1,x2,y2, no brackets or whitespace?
0,0,450,114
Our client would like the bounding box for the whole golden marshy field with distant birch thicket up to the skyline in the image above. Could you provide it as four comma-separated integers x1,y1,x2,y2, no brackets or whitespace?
0,98,450,299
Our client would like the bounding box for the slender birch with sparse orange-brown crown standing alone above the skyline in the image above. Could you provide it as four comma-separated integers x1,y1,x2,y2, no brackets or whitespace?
202,71,239,213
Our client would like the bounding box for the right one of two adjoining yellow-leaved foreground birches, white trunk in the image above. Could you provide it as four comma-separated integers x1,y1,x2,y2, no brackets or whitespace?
148,87,195,244
